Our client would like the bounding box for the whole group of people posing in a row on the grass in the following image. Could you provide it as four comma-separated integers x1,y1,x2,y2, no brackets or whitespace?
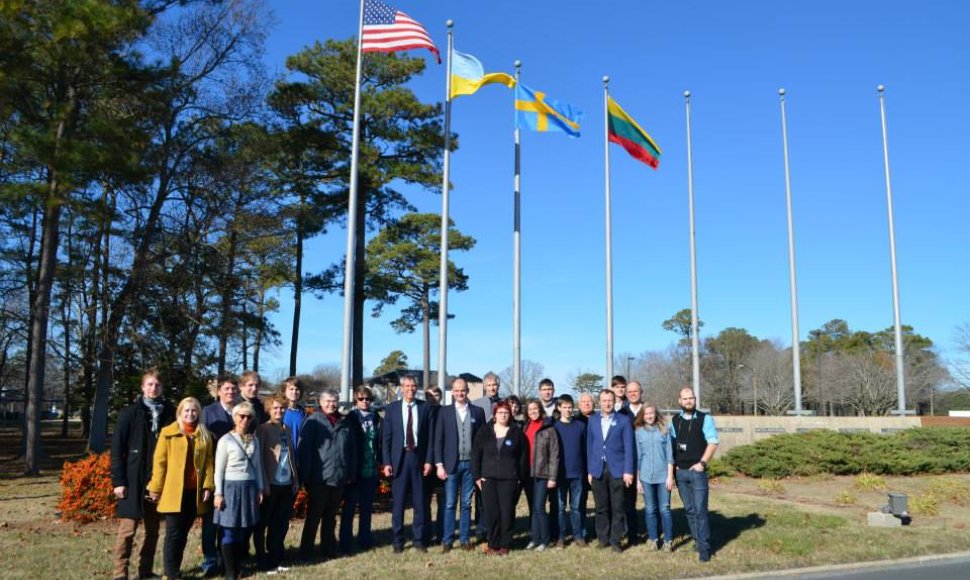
111,370,717,578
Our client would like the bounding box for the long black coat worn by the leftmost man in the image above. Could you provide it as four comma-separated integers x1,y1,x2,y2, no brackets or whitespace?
111,400,175,519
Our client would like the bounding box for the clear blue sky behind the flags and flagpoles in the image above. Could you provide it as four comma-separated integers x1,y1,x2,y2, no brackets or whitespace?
255,0,970,387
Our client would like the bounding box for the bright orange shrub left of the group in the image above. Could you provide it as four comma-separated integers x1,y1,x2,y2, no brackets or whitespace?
57,452,115,524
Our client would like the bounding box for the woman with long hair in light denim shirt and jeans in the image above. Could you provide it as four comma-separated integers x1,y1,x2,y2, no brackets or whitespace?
633,403,674,552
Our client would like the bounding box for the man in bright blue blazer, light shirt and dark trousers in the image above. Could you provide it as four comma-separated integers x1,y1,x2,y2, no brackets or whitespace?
586,389,637,553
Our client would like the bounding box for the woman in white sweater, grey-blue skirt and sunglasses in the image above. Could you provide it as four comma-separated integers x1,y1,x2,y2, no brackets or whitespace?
212,402,268,580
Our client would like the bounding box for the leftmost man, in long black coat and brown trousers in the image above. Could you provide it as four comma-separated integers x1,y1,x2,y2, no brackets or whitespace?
111,369,175,578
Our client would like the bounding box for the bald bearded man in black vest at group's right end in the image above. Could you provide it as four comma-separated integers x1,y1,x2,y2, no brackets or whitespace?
670,387,718,562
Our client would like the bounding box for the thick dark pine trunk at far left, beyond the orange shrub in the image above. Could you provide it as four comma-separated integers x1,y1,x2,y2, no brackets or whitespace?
24,182,64,475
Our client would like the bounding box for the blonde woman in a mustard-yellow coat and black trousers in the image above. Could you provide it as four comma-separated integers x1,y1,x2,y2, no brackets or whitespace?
148,397,216,578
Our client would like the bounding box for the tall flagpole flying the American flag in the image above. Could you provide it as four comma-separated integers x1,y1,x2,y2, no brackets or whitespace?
340,0,364,402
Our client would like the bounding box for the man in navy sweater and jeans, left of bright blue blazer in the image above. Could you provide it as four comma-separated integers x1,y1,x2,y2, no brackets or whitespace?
554,395,586,548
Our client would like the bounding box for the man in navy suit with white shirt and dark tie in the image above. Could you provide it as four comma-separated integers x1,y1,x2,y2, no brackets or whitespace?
381,376,434,554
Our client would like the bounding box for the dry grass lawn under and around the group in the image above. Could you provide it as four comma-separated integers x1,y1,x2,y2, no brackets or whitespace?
0,424,970,578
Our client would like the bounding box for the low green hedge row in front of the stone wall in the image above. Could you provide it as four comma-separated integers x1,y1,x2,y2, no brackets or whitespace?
724,427,970,478
